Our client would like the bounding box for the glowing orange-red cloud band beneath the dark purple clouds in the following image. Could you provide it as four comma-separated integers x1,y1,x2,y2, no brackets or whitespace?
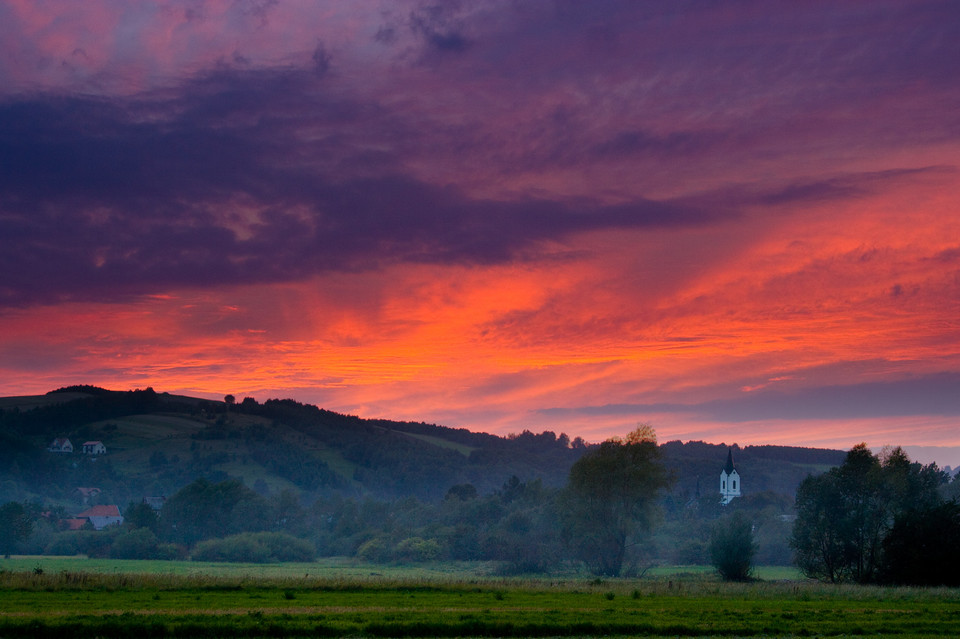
0,168,960,452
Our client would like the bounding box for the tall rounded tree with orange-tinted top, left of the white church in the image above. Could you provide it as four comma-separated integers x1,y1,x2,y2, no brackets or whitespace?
564,425,671,576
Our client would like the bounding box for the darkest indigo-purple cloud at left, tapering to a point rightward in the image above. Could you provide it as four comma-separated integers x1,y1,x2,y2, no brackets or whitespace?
0,71,711,304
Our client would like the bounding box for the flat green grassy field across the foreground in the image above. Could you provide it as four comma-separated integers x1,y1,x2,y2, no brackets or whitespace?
0,557,960,637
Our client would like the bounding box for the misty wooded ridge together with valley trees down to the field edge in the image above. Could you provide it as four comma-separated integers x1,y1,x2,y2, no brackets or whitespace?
0,386,872,574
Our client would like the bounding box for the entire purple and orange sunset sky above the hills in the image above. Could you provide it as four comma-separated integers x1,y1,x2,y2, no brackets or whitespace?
0,0,960,466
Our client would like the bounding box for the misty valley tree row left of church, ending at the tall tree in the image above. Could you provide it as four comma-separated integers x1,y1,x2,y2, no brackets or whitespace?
0,429,670,575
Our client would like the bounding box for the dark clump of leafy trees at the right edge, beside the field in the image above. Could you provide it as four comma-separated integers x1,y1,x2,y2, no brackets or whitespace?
791,444,960,586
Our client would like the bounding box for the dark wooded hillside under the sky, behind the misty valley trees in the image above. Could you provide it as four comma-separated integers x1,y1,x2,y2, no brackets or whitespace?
0,386,843,505
